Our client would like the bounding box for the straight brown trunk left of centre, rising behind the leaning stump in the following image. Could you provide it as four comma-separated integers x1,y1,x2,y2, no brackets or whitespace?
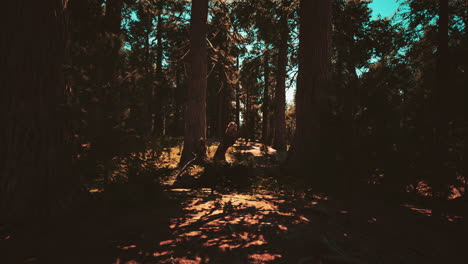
180,0,208,165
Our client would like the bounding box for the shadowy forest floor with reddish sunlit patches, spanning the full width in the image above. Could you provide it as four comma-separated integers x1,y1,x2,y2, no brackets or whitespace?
0,139,468,264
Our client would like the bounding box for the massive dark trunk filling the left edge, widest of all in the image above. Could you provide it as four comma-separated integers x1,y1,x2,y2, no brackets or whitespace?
0,0,80,218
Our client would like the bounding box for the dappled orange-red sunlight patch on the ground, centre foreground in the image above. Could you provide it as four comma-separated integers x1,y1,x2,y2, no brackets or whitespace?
146,194,309,263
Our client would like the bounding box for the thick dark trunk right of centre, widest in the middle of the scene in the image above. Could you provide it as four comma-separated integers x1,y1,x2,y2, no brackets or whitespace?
287,0,331,171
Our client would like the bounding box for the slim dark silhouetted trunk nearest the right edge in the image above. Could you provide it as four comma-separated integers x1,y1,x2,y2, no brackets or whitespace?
432,0,451,217
